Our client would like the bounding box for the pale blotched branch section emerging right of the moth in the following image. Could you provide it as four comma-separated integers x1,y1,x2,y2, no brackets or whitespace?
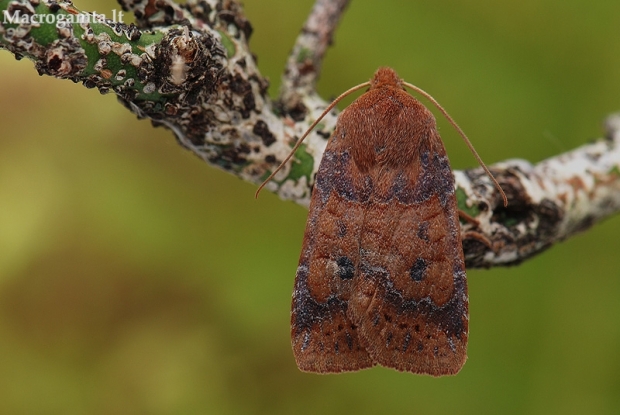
454,114,620,267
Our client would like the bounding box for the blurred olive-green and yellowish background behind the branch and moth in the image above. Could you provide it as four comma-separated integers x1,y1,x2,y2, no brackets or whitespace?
0,0,620,415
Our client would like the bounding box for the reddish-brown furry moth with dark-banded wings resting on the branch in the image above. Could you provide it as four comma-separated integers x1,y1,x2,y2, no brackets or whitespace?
256,68,503,376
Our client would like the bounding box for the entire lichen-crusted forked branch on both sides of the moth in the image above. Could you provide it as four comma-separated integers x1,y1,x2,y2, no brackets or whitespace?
0,0,620,267
